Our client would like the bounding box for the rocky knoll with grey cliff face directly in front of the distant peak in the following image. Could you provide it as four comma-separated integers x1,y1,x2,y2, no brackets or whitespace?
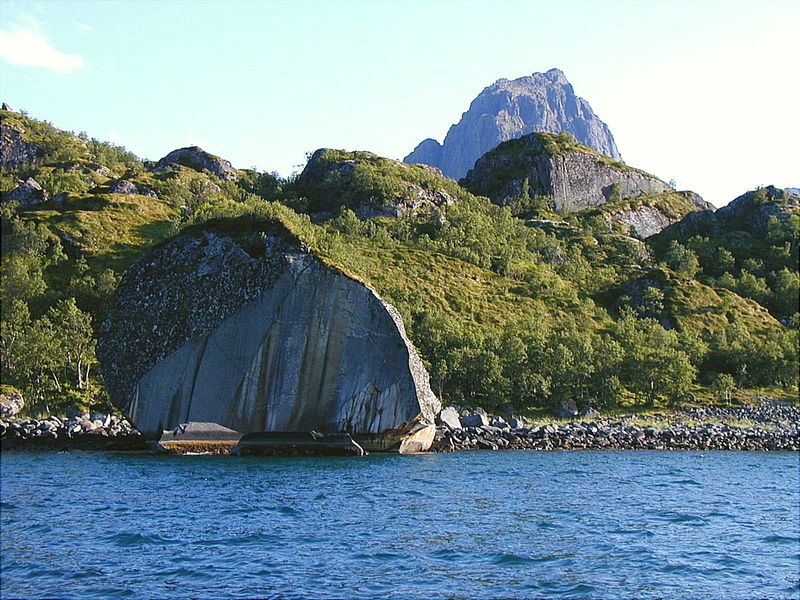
461,133,671,213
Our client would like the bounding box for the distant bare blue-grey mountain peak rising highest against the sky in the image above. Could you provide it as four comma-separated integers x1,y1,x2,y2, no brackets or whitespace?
403,69,620,179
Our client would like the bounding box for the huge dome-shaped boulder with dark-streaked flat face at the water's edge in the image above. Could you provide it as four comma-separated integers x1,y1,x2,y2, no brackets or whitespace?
98,220,440,451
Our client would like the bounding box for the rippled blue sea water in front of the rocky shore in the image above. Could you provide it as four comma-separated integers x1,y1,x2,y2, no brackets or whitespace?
0,451,800,599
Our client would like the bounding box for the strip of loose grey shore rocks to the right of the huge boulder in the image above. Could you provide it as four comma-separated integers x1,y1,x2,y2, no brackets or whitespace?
430,402,800,452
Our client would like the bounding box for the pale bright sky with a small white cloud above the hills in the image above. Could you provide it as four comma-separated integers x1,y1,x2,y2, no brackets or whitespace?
0,0,800,206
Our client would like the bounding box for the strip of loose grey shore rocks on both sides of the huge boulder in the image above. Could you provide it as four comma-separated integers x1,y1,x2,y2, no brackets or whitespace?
0,401,800,452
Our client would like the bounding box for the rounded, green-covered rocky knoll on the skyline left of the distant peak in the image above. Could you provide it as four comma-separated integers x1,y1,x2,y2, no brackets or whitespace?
297,148,463,219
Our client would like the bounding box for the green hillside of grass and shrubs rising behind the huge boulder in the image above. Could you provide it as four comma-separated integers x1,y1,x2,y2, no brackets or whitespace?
0,108,797,418
